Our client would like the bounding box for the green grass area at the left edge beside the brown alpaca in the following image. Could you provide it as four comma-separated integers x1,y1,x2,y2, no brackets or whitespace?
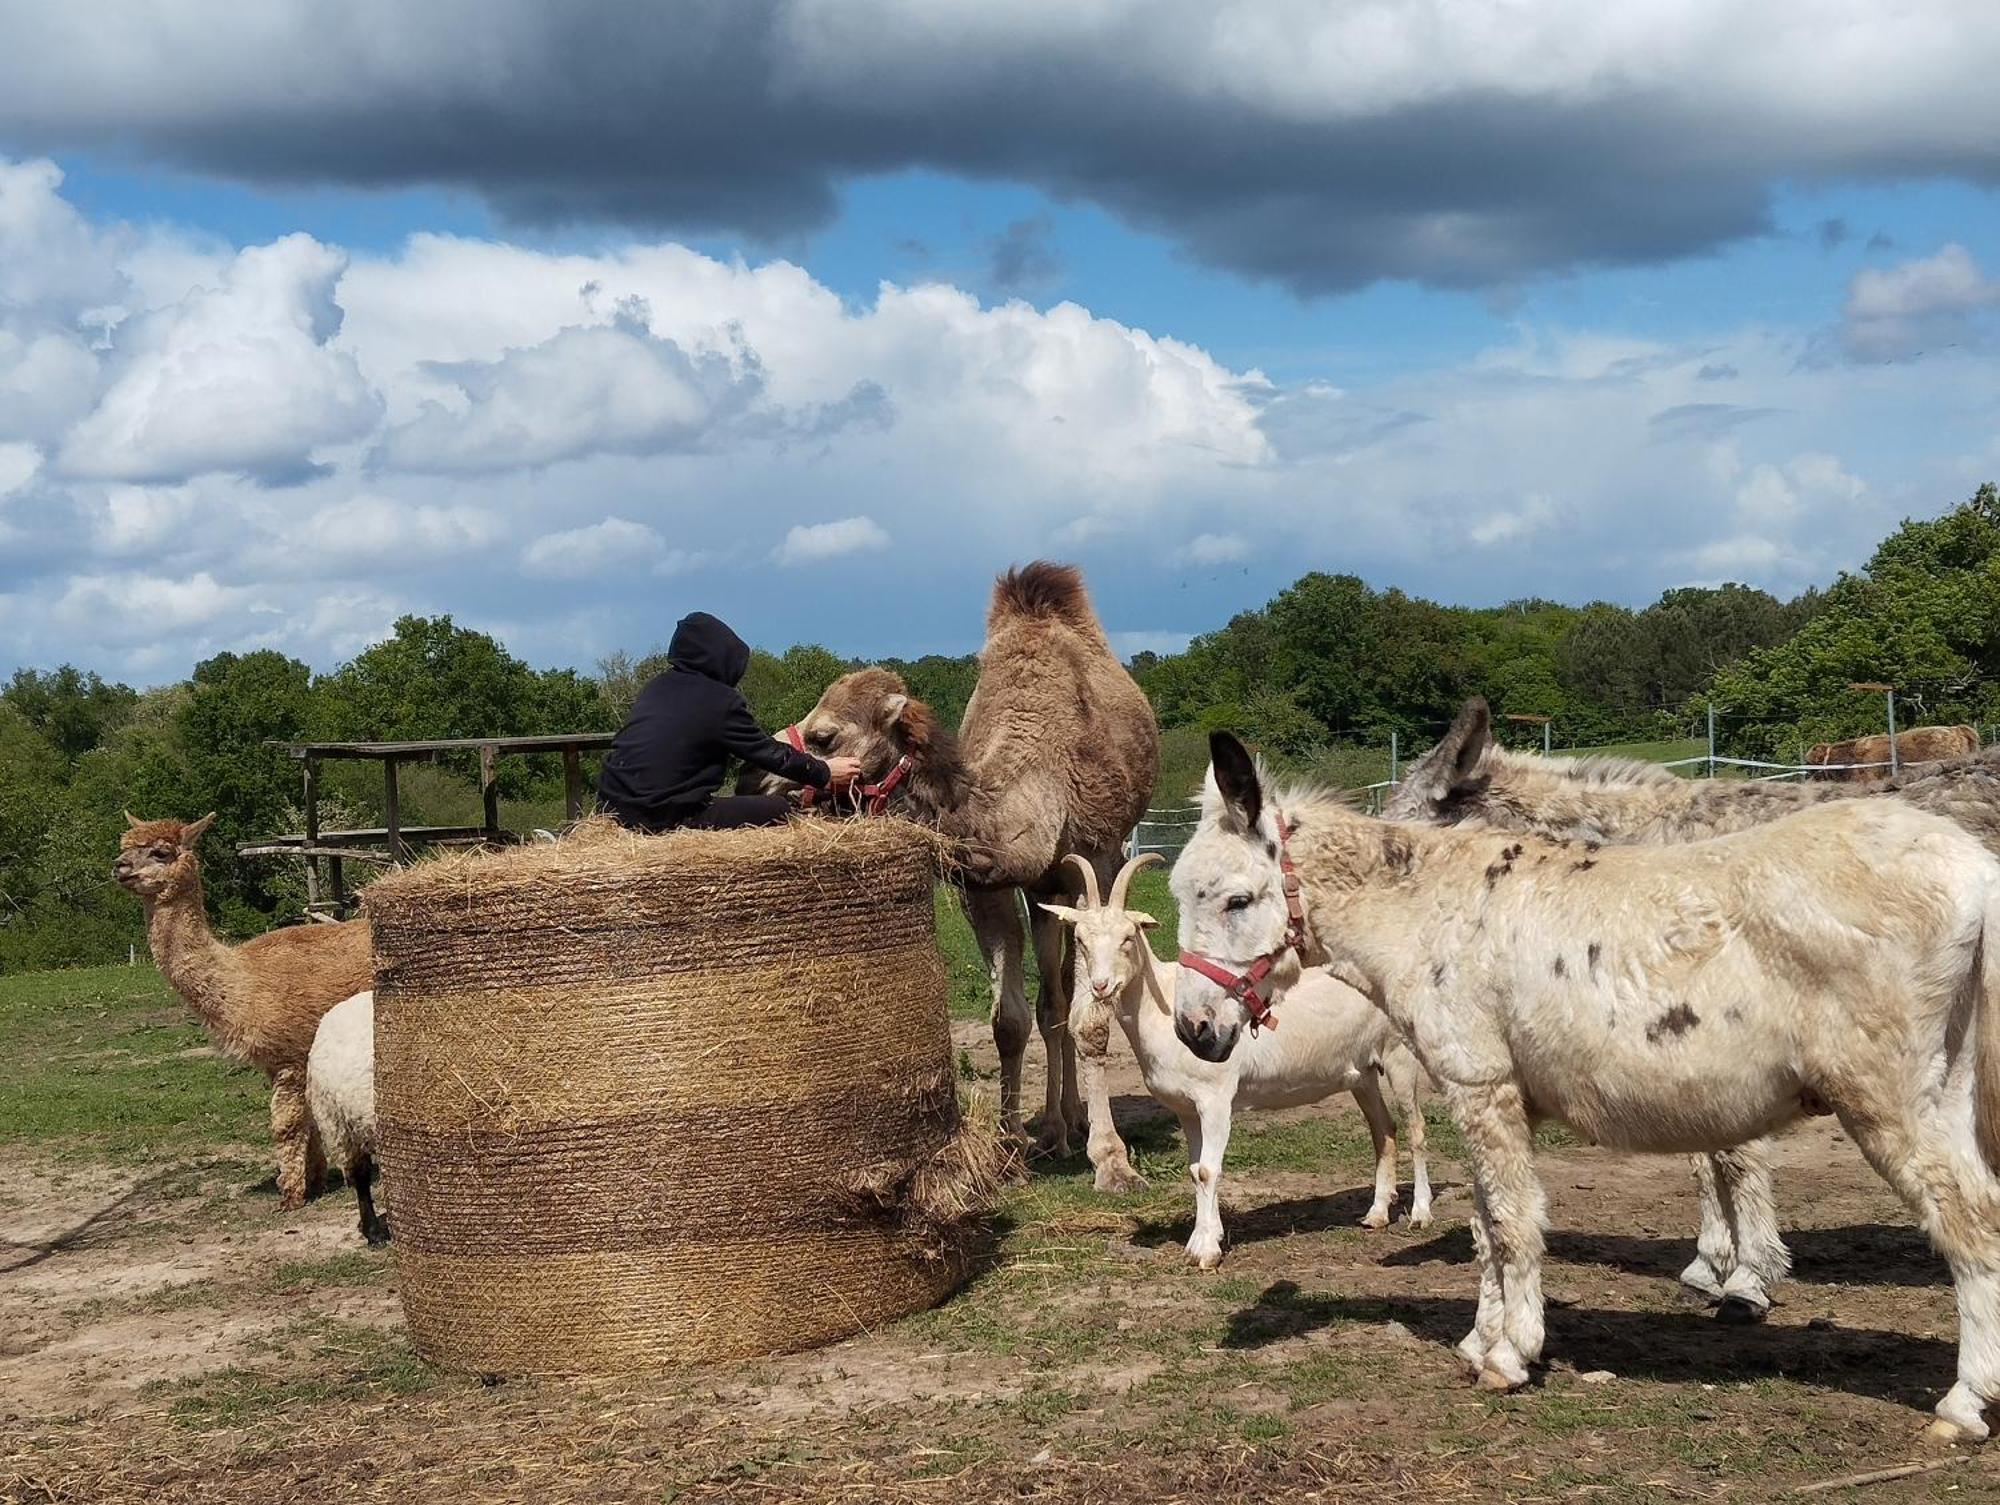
0,965,270,1159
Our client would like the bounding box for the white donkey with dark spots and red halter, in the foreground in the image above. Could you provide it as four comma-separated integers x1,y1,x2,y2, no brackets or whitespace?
1174,732,2000,1439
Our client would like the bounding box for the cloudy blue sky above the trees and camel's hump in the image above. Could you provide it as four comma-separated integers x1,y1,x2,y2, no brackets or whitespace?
0,0,2000,684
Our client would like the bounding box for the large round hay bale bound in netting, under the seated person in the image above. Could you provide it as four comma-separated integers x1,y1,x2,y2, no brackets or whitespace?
366,821,994,1375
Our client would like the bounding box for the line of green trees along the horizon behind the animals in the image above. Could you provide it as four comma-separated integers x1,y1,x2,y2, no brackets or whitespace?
0,484,2000,973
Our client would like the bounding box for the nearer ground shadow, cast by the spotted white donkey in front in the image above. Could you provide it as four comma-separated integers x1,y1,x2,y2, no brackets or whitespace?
1222,1281,1956,1409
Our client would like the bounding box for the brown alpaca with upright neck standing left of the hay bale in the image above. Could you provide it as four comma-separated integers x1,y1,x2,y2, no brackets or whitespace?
112,813,374,1211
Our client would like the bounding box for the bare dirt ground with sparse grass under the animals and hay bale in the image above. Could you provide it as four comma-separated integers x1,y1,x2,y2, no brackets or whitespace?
0,1025,2000,1505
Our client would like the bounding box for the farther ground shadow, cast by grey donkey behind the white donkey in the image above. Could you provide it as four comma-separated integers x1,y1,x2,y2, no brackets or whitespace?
1382,1223,1950,1285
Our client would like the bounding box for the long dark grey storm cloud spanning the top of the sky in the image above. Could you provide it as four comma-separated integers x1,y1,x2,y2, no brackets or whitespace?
0,0,2000,292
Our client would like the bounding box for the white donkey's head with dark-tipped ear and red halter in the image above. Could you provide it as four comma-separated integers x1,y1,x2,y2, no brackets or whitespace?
1172,732,1300,1061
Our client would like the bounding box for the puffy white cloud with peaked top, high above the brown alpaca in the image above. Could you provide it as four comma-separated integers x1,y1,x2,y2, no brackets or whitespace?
60,234,382,482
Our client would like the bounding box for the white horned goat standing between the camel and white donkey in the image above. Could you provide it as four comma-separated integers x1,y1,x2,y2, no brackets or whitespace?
1042,853,1430,1269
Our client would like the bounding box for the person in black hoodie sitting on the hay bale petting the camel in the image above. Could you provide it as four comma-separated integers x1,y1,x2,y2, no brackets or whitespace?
598,612,862,831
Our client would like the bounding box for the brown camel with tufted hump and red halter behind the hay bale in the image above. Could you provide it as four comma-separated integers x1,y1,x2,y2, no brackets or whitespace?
760,560,1160,1152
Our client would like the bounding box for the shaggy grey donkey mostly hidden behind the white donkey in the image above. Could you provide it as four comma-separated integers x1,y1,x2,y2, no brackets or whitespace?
1382,696,2000,1321
